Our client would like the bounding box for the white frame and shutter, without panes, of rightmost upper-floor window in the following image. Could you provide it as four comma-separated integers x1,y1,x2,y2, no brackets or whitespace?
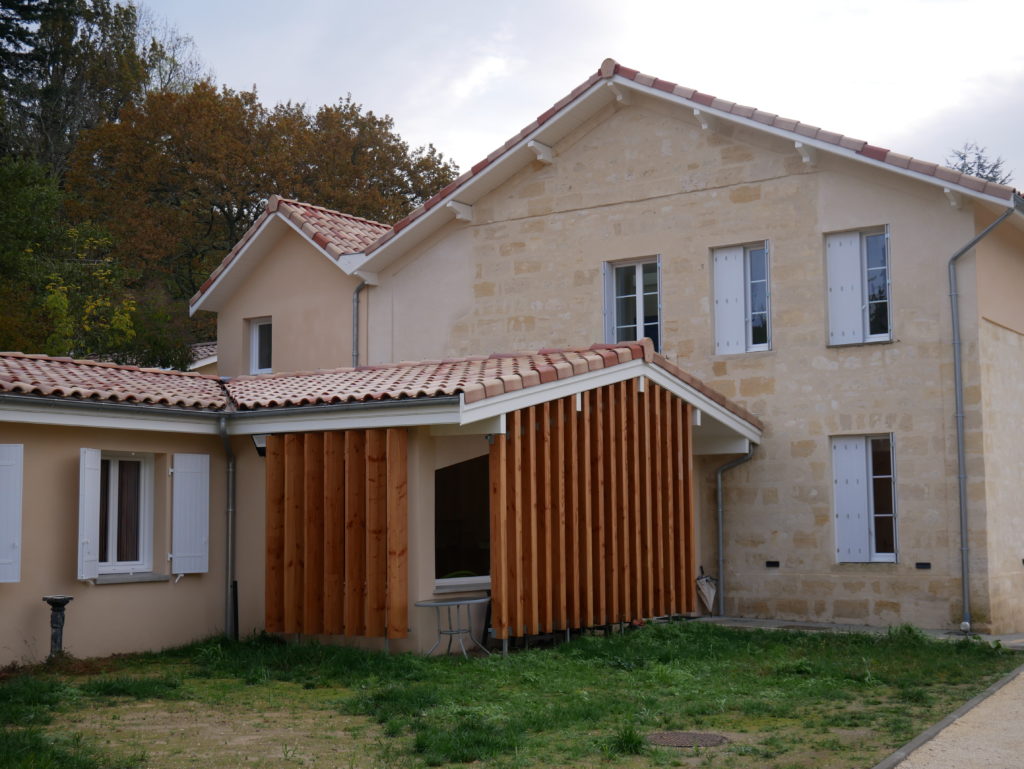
825,224,893,346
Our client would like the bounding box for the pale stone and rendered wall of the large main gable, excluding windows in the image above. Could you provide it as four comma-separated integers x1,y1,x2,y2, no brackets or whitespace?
370,98,987,628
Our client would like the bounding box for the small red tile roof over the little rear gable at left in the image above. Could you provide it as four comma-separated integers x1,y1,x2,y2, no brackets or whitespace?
189,195,391,304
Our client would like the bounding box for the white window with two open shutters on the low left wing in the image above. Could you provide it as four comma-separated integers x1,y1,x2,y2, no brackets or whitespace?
78,448,210,580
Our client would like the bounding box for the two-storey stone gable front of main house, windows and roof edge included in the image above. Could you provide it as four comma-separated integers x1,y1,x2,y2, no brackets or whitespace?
193,60,1024,632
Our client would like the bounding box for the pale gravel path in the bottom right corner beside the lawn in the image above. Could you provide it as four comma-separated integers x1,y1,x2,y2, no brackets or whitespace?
898,671,1024,769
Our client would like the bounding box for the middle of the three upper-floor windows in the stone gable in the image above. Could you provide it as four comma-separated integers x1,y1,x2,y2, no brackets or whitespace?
713,242,771,355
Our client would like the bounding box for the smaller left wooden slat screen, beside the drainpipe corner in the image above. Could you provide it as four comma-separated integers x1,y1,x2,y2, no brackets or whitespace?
265,429,409,638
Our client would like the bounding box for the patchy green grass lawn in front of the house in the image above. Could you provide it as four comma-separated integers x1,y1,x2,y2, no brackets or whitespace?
0,623,1022,769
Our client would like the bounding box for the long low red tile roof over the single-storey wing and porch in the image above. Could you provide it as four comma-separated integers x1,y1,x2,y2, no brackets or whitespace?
0,339,763,429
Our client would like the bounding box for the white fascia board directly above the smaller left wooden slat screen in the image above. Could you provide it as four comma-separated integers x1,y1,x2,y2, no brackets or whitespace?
227,401,459,435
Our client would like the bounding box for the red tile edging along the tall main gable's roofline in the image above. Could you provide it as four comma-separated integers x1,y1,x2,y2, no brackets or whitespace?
366,58,1015,260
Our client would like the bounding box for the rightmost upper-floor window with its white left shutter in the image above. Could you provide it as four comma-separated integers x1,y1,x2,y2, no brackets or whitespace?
825,229,892,345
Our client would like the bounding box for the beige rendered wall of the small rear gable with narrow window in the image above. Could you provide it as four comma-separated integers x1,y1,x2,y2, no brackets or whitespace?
211,228,359,377
